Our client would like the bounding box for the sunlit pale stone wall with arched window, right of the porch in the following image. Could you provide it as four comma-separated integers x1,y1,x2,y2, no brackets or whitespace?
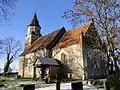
52,43,84,79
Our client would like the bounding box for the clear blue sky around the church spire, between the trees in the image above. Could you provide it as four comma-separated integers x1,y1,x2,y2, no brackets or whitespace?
0,0,74,71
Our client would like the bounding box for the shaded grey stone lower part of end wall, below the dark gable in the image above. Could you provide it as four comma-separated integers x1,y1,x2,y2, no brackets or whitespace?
83,45,106,79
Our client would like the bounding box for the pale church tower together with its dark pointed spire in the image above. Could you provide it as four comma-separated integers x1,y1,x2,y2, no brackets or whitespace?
25,13,42,49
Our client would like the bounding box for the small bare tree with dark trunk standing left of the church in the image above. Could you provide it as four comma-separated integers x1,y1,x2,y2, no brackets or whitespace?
1,37,21,73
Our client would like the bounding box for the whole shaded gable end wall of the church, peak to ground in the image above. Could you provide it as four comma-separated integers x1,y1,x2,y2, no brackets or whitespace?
82,27,106,79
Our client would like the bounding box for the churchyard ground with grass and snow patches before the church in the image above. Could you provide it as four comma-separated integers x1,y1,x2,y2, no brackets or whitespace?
0,75,105,90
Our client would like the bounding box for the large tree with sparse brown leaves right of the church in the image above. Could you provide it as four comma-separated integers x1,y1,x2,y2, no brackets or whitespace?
64,0,120,72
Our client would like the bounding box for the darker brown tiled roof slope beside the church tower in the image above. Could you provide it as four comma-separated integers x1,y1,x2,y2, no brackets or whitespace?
20,27,65,56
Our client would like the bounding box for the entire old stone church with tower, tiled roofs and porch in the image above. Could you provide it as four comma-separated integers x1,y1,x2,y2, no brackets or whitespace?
18,13,106,80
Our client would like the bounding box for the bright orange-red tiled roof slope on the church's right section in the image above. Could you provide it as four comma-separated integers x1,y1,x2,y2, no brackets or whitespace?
53,22,92,49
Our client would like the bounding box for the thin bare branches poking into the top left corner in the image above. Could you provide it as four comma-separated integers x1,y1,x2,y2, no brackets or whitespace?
0,0,17,22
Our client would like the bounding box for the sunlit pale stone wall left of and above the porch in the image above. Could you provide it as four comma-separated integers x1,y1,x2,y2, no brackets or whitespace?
19,48,49,77
